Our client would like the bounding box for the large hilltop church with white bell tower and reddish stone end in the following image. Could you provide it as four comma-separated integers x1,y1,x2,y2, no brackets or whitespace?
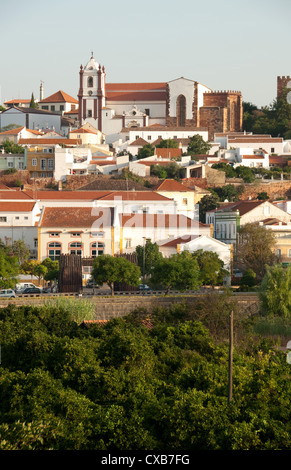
78,54,242,144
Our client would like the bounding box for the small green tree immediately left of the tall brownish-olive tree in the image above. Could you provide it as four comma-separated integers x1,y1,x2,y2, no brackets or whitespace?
192,250,228,286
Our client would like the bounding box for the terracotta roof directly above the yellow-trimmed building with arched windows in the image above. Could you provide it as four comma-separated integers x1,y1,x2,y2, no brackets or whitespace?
39,207,113,230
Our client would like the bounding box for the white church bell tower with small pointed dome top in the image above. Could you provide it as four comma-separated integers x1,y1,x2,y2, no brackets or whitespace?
78,53,105,131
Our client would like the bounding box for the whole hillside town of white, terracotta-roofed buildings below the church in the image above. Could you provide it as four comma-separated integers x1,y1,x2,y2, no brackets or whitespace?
0,55,291,287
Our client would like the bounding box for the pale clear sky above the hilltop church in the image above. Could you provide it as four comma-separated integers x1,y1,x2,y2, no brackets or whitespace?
0,0,291,107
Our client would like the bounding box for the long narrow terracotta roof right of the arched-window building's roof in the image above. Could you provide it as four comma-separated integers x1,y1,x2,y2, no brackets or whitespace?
119,214,200,230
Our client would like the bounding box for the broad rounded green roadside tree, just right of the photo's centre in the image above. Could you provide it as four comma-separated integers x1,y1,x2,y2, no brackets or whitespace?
151,251,200,293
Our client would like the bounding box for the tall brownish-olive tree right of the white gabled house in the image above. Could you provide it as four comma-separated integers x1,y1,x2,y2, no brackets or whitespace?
235,223,277,280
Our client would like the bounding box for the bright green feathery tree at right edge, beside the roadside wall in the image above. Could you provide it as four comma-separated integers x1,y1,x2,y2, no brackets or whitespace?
259,264,291,318
